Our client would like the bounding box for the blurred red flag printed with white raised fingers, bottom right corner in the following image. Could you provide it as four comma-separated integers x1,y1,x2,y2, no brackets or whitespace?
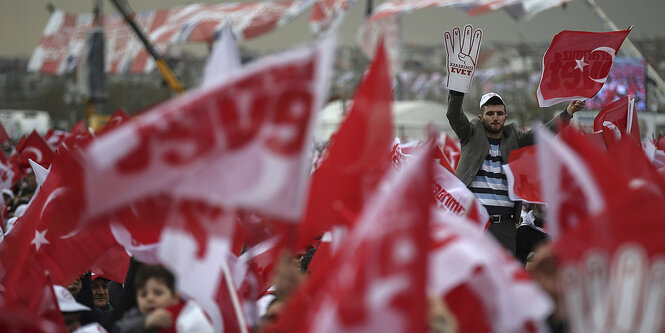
554,191,665,332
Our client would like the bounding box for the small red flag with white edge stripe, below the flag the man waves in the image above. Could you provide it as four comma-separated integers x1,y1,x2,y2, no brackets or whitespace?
593,96,640,142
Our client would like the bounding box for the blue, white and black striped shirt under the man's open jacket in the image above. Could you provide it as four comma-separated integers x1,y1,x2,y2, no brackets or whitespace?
469,137,515,215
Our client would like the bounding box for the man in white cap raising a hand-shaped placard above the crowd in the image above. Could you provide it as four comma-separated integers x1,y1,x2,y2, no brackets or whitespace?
444,25,584,254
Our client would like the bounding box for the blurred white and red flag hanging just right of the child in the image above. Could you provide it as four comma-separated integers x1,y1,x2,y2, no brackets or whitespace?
159,203,247,332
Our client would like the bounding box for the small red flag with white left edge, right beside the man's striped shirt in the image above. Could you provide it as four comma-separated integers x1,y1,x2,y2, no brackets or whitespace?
502,145,544,203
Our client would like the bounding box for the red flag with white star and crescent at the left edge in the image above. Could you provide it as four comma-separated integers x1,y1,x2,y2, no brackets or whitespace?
0,144,118,300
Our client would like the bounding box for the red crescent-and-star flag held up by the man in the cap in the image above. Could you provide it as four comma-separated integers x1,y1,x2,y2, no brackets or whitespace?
536,28,631,107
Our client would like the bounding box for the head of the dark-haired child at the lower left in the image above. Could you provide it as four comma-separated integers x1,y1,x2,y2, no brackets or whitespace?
134,265,180,314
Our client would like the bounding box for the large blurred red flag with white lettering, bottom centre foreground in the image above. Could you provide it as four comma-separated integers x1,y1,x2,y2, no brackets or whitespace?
278,143,433,332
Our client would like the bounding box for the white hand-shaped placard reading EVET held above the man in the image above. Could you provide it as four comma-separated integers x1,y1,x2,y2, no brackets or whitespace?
444,24,483,93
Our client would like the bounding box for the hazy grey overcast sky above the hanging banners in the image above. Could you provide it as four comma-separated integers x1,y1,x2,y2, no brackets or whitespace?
0,0,665,57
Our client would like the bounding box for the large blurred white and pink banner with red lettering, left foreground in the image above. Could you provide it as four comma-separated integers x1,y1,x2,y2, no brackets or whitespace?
74,39,333,226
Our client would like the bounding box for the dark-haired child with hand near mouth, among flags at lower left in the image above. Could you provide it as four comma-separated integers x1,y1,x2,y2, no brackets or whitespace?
113,265,213,333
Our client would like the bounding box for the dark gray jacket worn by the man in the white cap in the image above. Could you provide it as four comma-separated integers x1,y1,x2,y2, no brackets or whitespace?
446,92,572,213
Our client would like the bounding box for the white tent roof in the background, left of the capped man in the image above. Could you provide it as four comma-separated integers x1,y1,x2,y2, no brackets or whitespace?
316,100,476,141
